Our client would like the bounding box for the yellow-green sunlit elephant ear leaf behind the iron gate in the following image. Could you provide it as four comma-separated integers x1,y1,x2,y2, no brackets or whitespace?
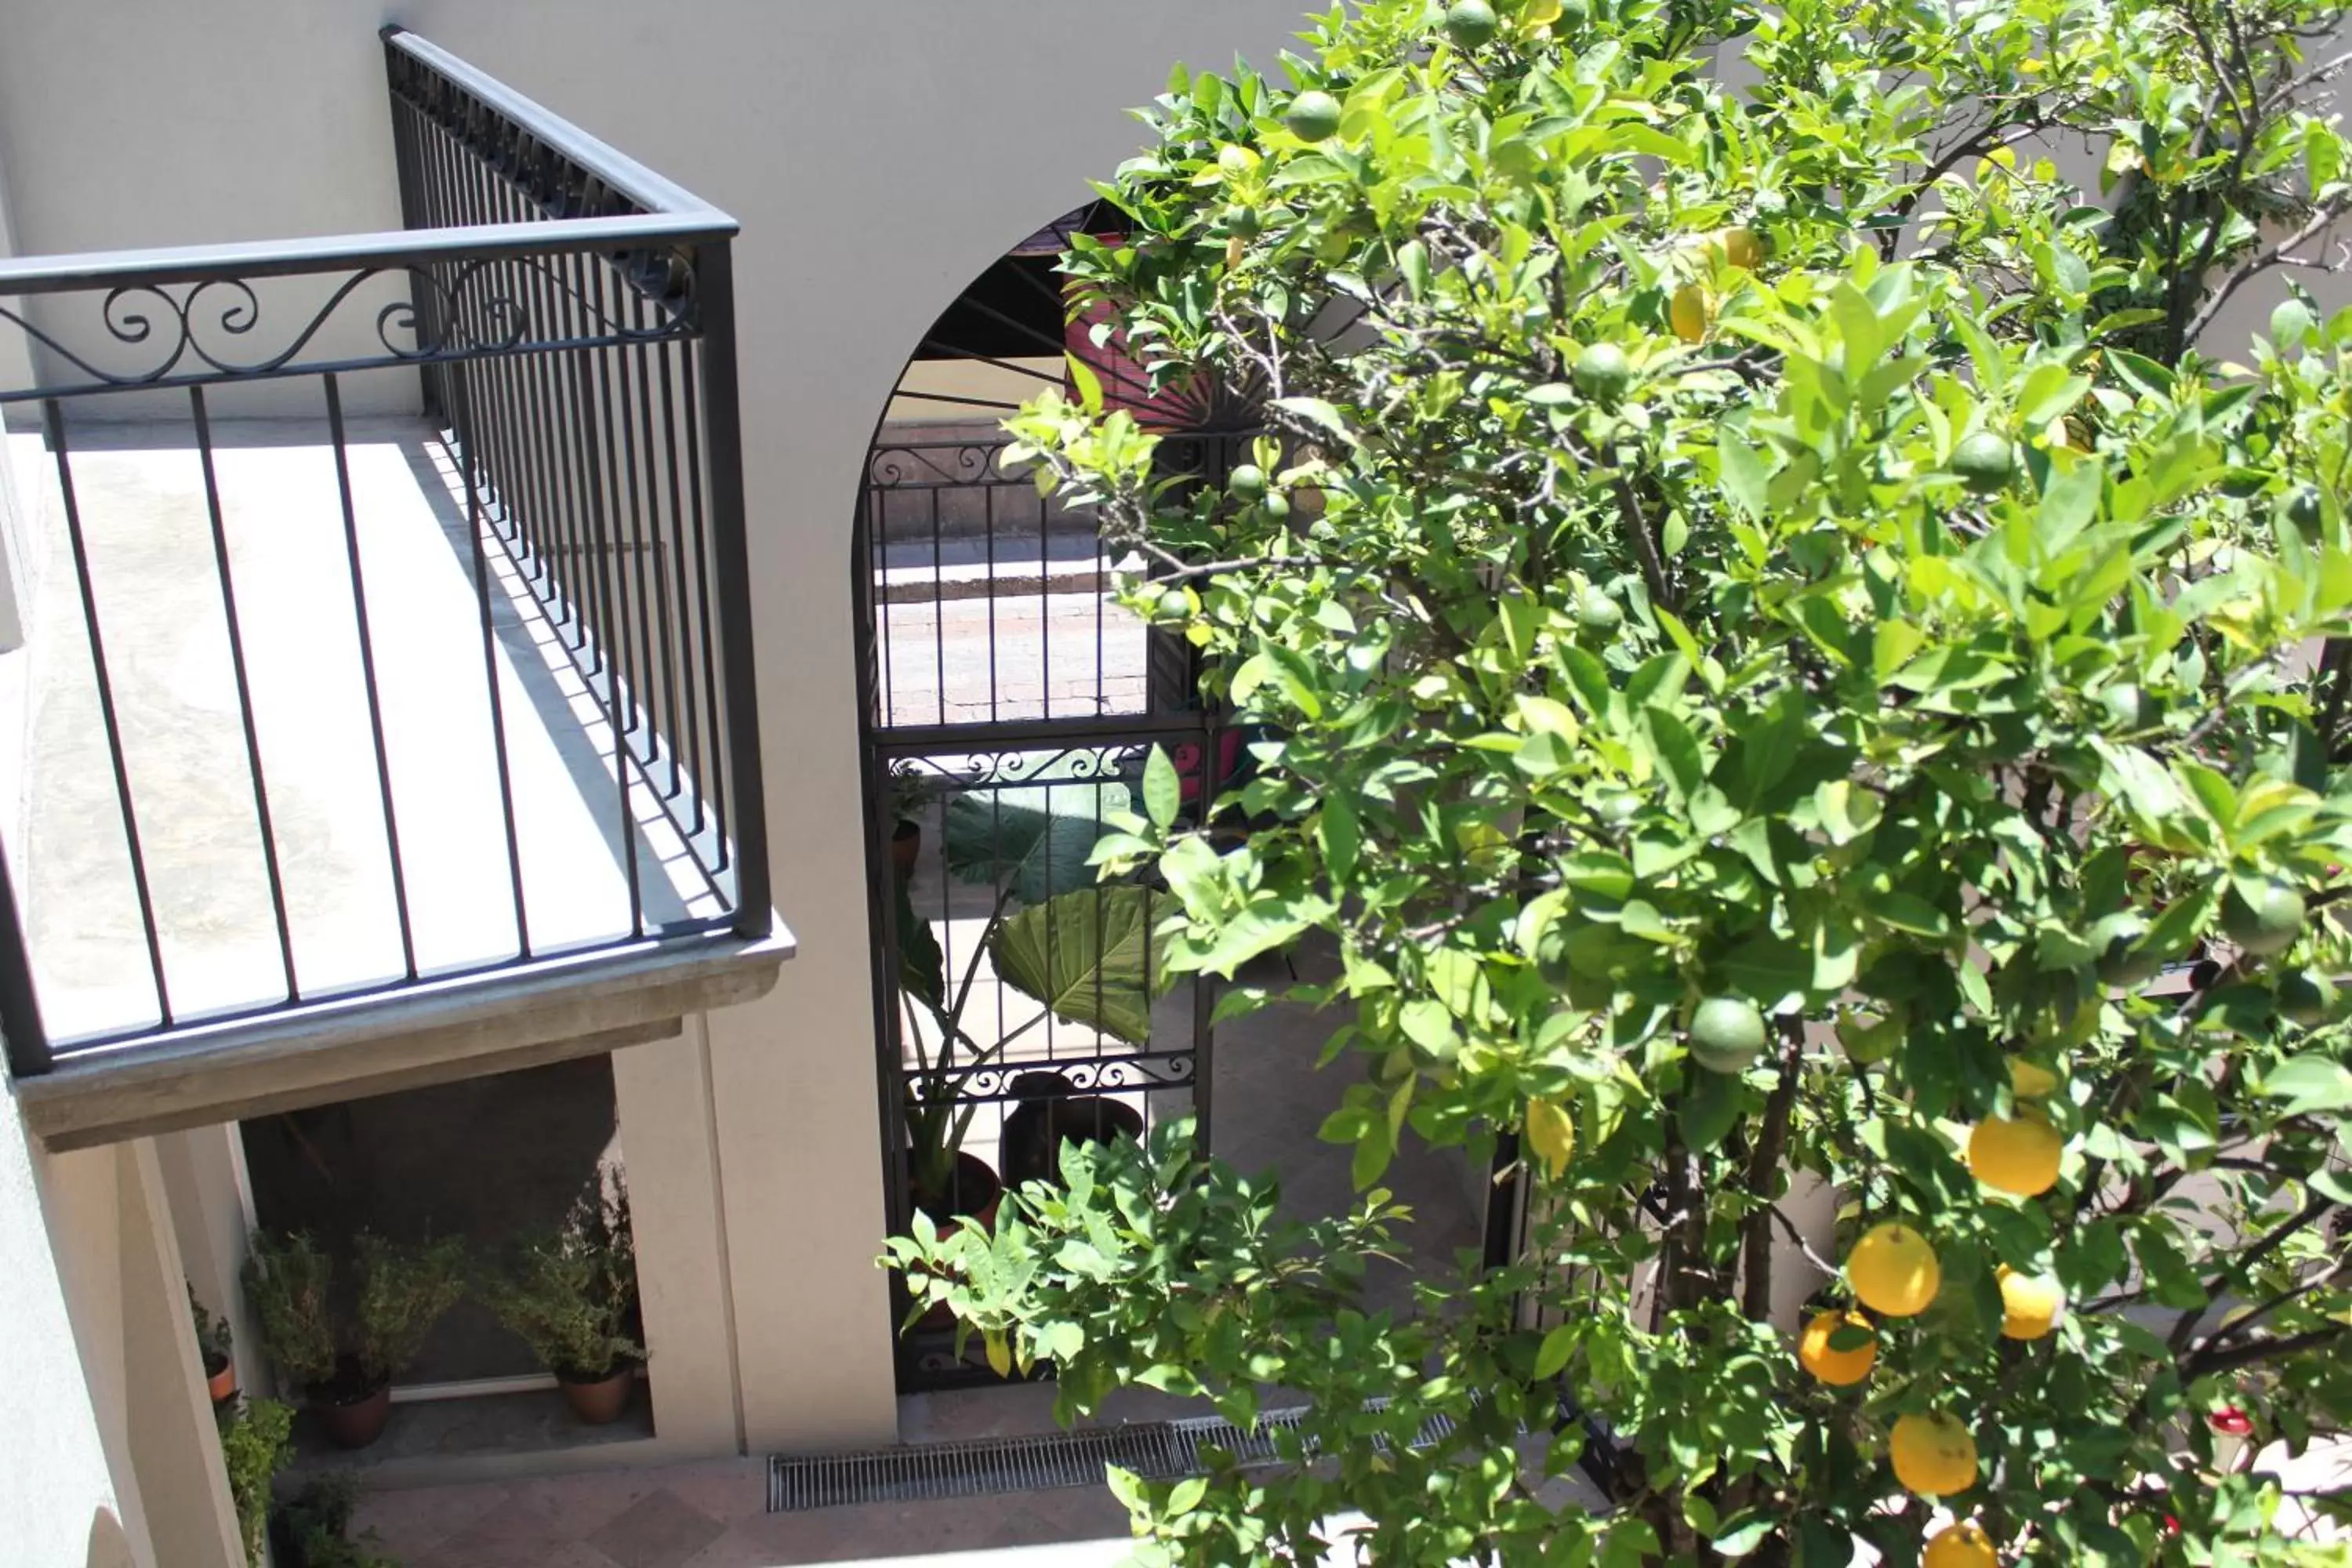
988,886,1174,1046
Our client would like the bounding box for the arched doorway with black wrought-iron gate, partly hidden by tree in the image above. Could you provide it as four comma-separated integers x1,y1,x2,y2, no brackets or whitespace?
854,205,1256,1392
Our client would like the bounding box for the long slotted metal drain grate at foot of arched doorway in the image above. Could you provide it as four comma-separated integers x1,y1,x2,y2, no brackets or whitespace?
767,1406,1454,1514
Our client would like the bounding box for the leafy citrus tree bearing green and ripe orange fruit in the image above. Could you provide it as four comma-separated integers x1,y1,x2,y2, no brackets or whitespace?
891,0,2352,1568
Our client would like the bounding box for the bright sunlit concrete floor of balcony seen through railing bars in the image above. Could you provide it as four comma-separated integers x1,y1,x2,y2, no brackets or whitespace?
7,421,715,1041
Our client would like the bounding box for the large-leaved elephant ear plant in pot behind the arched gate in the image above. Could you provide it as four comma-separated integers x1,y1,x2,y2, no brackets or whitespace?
894,753,1169,1232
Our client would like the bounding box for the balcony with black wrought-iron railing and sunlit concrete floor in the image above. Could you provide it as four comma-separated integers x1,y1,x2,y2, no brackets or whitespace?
0,28,790,1147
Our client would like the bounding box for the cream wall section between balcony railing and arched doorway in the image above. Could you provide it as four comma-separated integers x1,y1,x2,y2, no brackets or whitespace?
374,0,1301,1450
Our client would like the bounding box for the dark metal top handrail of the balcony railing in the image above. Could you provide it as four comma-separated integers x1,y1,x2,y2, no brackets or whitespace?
0,26,739,296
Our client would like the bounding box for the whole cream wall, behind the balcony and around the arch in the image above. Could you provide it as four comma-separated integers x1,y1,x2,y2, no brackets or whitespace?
0,0,1305,1450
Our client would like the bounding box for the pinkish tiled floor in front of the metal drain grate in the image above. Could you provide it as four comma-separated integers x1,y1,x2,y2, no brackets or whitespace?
343,1460,1127,1568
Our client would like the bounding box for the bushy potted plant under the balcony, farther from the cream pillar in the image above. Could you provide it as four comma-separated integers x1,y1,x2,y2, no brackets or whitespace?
245,1232,466,1448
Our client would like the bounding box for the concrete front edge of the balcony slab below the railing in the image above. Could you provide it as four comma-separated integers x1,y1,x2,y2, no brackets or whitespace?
12,928,795,1149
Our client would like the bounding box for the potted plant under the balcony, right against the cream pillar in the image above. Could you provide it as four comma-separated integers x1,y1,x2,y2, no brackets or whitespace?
477,1175,644,1427
